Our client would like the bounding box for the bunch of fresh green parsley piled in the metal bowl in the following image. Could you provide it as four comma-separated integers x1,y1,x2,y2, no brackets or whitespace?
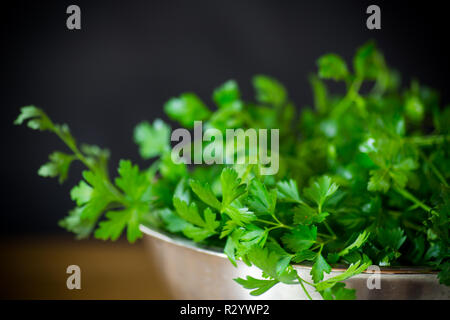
16,42,450,299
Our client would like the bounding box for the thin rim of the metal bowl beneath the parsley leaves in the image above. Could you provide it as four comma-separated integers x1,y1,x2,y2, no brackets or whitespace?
139,224,438,275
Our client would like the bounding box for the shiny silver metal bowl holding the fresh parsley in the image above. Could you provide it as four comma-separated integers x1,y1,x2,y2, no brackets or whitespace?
141,226,450,300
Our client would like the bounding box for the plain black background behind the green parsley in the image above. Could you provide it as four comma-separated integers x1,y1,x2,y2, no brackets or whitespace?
0,0,450,234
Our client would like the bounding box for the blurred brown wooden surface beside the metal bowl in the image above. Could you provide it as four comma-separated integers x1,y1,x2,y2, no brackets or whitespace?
0,236,170,299
